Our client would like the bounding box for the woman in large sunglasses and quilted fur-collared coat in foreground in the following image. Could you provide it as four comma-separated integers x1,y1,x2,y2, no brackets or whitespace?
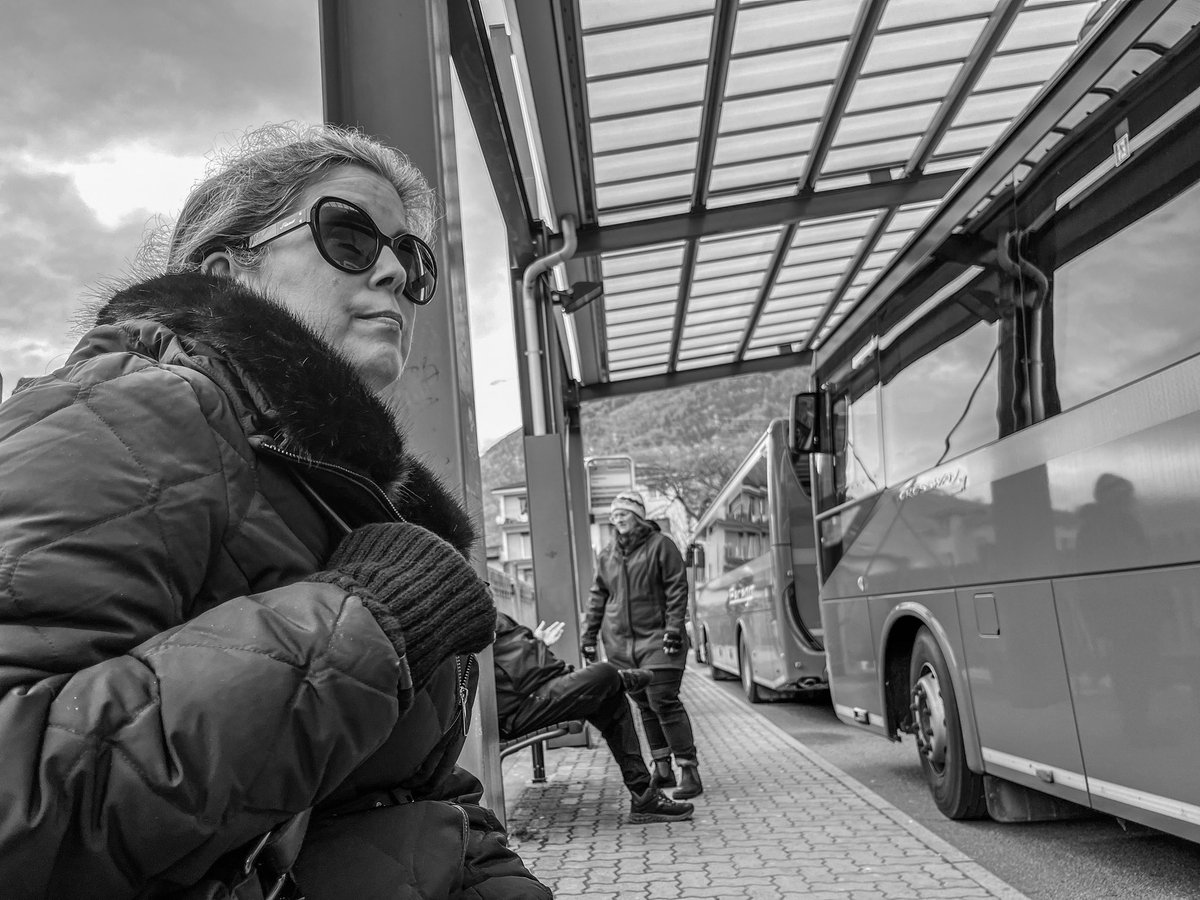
0,127,550,900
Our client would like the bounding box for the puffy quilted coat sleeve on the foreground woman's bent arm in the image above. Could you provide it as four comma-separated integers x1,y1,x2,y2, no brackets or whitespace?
0,356,400,898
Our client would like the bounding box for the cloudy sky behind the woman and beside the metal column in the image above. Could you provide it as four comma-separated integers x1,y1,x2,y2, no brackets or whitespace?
0,0,521,448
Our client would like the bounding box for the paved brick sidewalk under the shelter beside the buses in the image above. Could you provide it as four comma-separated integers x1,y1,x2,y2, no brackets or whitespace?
505,670,1024,900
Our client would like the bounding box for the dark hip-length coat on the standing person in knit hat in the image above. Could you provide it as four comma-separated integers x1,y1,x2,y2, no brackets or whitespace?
583,522,688,668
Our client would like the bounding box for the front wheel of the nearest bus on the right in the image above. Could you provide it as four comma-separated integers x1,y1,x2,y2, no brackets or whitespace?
908,628,986,818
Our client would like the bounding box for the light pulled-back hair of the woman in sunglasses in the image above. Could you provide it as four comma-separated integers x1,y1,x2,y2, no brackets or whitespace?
157,122,437,271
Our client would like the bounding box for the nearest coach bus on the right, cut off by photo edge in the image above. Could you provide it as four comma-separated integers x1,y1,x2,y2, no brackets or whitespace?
792,4,1200,840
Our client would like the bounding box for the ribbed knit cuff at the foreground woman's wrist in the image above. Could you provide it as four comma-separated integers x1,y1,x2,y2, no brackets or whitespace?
310,522,496,691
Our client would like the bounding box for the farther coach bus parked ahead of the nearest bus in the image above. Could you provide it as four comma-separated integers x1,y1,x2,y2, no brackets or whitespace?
688,419,828,703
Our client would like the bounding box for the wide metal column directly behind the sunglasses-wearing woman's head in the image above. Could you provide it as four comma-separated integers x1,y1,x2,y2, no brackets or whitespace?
320,0,504,815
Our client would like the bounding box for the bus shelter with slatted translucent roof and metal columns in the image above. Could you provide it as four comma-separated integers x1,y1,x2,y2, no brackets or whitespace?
320,0,1177,809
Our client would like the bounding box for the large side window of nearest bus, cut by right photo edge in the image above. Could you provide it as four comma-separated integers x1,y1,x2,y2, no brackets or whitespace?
1051,175,1200,409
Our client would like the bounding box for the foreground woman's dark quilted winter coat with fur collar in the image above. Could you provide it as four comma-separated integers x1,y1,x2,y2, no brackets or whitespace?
0,275,540,899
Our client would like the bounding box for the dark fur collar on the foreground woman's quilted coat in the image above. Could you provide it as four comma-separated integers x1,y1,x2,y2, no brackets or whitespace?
95,272,476,556
